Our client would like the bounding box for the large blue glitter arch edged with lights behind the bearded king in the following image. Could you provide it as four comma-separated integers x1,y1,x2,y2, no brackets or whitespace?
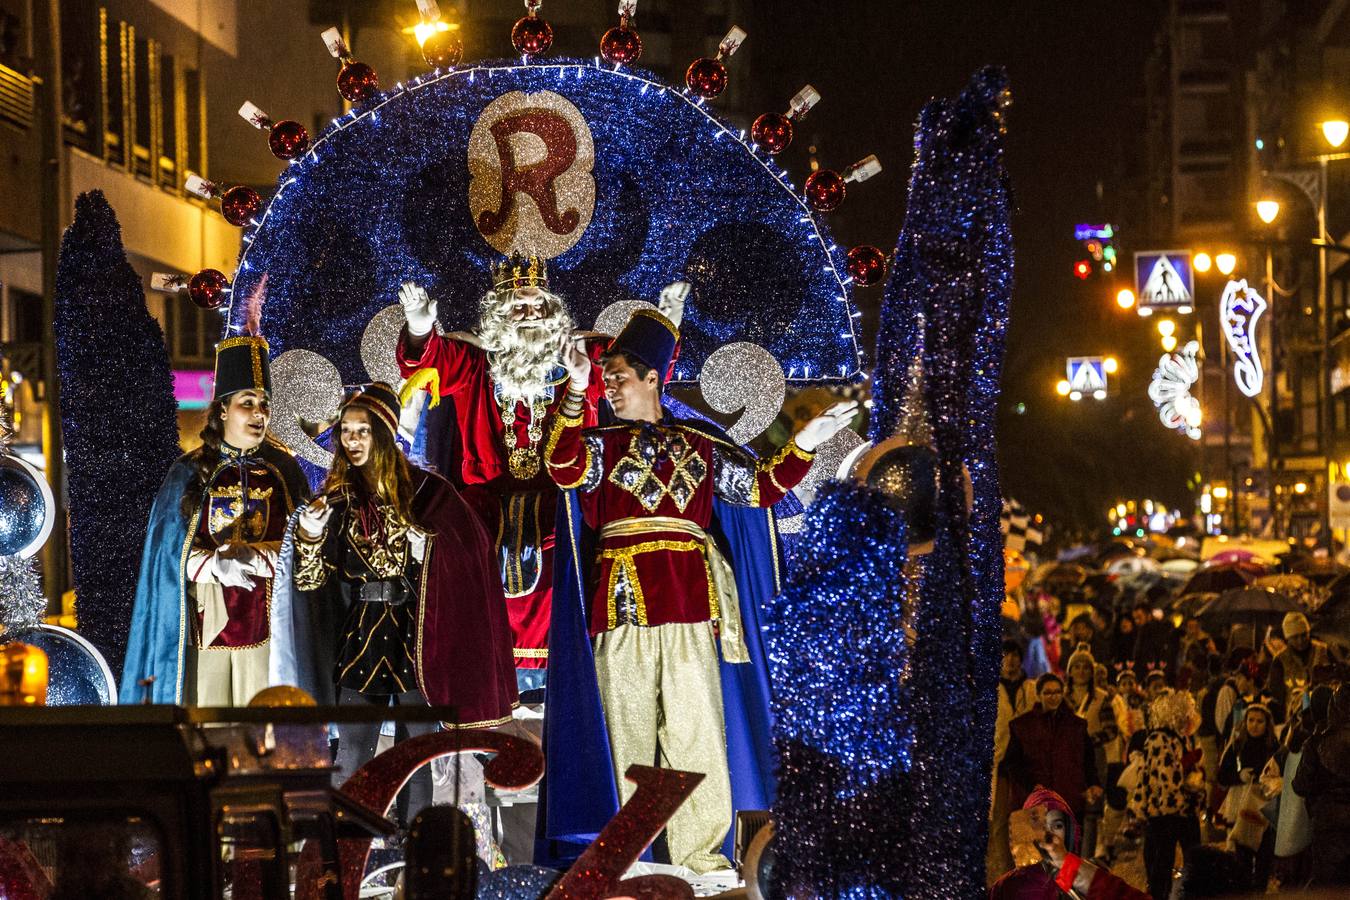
227,61,861,383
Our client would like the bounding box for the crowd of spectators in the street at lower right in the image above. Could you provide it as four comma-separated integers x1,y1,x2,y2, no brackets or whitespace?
987,545,1350,900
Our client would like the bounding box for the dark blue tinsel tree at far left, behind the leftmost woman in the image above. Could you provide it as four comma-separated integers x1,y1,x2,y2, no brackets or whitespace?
55,190,181,672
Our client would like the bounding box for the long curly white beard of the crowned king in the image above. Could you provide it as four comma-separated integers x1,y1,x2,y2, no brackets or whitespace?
478,291,572,402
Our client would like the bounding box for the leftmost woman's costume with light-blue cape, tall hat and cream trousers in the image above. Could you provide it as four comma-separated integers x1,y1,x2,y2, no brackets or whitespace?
120,335,309,706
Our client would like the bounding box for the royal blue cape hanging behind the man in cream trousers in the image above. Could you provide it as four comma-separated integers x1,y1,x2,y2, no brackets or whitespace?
535,424,779,866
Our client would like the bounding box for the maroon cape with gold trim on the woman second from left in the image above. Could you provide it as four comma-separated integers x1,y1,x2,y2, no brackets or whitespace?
301,467,518,727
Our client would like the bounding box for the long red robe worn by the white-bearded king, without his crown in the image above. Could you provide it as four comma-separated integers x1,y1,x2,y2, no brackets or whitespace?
398,331,608,669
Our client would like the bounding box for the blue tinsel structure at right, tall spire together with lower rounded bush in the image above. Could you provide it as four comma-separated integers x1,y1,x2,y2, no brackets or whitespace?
768,69,1013,900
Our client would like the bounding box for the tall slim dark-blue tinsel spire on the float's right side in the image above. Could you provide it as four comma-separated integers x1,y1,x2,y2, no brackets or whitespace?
872,67,1013,900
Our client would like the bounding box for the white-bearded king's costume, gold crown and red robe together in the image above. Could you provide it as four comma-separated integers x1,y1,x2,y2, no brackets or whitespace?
398,255,605,674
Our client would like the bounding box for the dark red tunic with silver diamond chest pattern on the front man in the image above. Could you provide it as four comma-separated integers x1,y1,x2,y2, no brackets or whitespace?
545,416,814,636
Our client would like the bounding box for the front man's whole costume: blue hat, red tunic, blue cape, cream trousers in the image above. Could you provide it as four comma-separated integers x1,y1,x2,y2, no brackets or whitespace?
540,309,814,872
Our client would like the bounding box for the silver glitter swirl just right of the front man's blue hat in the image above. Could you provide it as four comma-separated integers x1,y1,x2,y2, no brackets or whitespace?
698,341,787,444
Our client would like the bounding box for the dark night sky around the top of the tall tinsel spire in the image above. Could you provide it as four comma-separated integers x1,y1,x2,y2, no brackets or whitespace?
750,0,1196,539
